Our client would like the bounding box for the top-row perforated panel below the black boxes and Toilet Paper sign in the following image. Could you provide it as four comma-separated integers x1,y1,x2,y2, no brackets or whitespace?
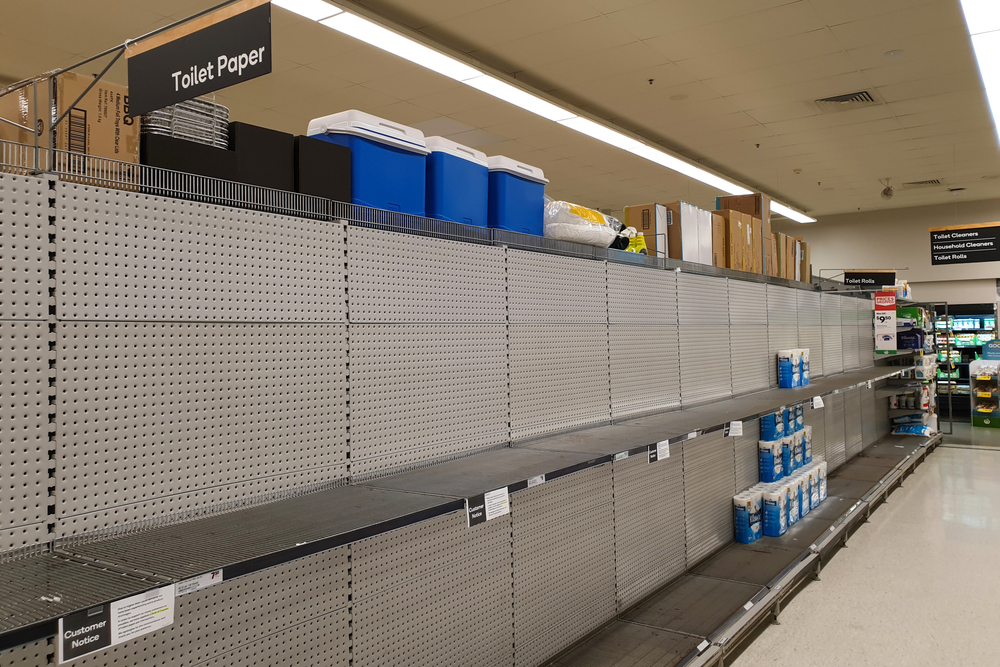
56,182,347,322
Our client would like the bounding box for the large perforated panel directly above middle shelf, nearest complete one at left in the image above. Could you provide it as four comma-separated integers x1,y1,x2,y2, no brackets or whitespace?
56,322,347,535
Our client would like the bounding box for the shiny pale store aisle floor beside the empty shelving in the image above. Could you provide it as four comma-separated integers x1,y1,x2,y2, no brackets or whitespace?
726,446,1000,667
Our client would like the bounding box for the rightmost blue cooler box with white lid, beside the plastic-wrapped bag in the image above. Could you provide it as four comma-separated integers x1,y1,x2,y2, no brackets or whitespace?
487,155,548,236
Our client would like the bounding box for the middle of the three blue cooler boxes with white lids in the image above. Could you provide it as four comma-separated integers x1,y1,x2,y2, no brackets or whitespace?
427,137,490,227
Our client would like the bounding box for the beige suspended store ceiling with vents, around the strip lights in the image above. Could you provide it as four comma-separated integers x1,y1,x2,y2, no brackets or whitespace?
0,0,1000,215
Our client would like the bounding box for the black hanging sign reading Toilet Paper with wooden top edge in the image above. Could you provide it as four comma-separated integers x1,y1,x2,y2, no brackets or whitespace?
128,0,271,116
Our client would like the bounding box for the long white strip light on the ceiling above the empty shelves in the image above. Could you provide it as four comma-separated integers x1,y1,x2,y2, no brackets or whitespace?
273,0,800,209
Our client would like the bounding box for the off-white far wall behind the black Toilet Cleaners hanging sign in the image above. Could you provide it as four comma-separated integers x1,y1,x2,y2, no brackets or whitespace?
772,199,1000,303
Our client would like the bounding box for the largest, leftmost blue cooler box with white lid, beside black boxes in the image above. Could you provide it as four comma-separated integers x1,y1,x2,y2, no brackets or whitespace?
307,111,428,216
